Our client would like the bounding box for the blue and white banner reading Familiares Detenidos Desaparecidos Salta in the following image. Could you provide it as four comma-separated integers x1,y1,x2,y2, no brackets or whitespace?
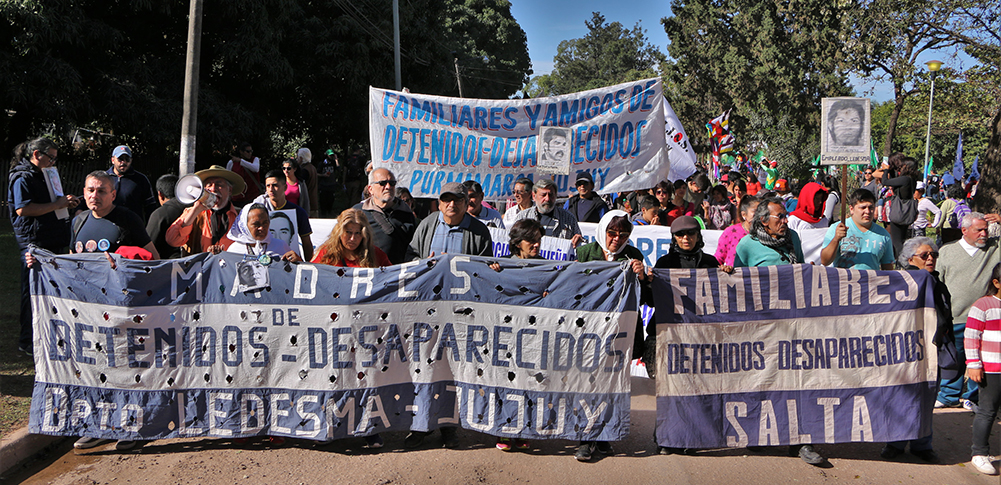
654,265,937,448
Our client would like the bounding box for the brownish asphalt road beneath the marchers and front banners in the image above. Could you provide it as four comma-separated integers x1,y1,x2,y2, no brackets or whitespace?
8,378,1001,485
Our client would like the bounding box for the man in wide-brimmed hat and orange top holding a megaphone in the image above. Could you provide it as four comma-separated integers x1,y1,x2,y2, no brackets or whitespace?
167,165,246,255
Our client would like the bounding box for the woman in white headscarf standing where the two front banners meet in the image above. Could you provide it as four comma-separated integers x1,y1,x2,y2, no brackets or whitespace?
574,210,649,461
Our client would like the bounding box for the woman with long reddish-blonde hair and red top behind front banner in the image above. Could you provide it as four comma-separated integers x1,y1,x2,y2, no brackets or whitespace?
312,209,392,268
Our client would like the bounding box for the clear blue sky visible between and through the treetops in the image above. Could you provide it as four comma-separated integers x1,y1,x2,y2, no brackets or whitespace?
511,0,974,101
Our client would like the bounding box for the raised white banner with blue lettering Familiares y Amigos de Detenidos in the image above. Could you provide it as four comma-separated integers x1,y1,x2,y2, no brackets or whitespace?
368,78,664,200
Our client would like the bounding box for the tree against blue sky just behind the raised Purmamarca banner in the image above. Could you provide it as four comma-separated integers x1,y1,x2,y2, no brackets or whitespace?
526,12,665,96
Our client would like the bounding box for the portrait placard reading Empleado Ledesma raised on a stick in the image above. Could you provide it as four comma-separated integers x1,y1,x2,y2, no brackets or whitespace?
820,98,871,164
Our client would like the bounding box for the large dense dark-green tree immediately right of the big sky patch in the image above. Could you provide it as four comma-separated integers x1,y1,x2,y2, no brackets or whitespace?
661,0,851,175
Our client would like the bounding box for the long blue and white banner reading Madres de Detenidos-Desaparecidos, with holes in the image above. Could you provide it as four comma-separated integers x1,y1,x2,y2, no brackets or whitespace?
30,251,639,440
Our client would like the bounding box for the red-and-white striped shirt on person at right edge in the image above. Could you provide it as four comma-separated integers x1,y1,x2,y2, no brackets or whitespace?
963,296,1001,374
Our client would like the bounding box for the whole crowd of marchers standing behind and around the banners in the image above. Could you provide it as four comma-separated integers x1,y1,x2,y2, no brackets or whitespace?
8,138,1001,474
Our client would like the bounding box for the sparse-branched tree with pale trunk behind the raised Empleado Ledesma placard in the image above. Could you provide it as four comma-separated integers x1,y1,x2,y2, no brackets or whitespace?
848,0,959,157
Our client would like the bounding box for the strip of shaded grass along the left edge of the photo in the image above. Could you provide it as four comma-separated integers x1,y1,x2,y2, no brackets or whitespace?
0,217,35,436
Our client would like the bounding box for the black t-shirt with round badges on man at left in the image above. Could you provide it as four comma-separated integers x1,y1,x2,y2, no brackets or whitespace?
70,206,150,253
